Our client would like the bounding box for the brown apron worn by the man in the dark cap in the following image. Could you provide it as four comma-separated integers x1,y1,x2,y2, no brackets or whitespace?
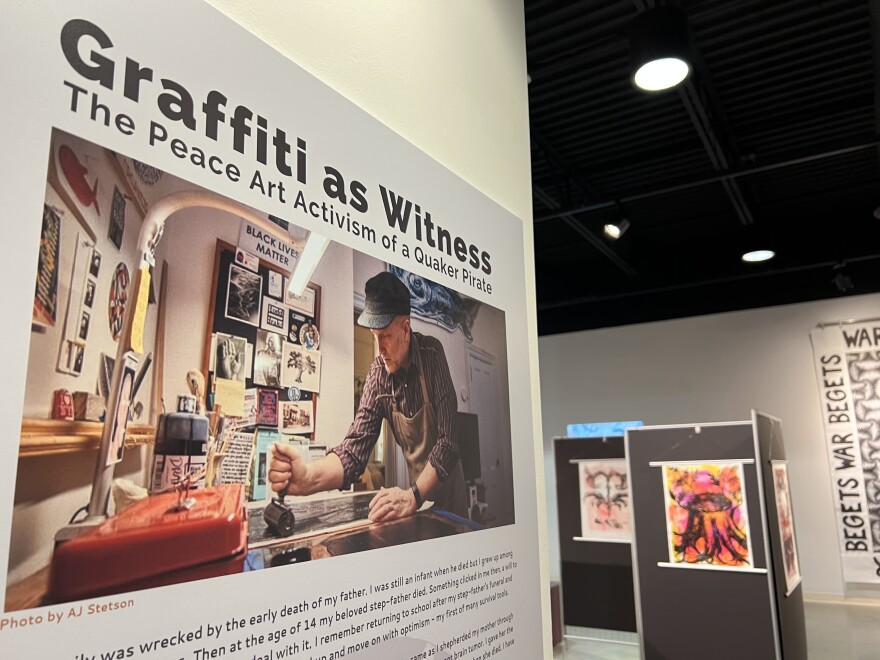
391,368,468,518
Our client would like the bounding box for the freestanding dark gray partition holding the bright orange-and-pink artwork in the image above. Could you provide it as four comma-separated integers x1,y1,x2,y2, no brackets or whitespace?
626,422,807,660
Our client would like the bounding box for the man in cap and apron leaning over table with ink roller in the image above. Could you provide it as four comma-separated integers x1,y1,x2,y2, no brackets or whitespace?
269,272,467,522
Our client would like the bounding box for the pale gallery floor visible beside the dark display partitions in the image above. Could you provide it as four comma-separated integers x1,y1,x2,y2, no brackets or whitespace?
553,603,880,660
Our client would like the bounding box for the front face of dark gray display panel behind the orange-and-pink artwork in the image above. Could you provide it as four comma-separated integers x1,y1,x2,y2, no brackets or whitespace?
626,422,780,660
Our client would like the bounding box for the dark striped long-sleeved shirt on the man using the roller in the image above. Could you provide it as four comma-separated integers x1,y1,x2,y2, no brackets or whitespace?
328,332,458,488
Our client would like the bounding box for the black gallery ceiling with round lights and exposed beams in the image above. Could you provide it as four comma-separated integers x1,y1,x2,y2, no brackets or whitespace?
525,0,880,334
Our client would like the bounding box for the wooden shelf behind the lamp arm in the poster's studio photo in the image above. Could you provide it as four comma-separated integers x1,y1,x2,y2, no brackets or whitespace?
18,419,156,457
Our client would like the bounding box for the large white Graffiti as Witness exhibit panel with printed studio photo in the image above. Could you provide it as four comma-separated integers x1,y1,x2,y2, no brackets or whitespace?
0,0,547,660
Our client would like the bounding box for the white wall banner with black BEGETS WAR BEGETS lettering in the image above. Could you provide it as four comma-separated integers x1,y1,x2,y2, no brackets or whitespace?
810,321,880,583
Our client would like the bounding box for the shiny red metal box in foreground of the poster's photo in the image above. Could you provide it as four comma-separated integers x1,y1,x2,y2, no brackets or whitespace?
49,484,247,603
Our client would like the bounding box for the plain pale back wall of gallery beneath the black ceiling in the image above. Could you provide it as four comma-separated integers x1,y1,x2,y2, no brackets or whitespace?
539,294,880,598
